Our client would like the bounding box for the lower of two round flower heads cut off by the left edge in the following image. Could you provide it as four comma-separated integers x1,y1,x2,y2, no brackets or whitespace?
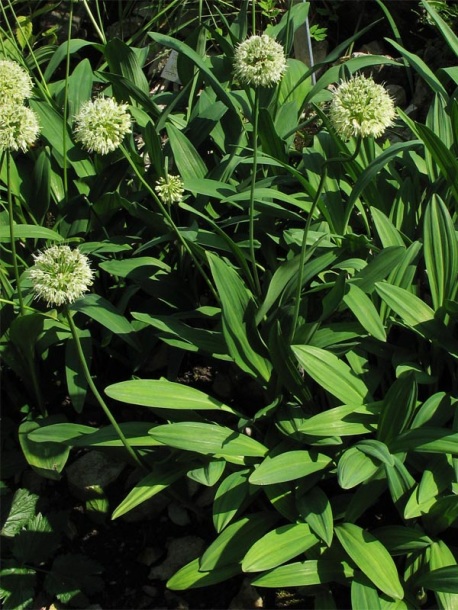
0,102,40,152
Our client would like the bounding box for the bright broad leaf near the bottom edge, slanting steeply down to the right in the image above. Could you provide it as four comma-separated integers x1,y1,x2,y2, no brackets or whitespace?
335,523,404,599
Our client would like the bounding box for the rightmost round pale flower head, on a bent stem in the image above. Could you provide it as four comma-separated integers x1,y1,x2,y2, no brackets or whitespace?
329,76,395,140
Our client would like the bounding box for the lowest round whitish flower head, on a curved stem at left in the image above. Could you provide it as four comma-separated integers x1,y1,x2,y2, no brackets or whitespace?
29,246,94,306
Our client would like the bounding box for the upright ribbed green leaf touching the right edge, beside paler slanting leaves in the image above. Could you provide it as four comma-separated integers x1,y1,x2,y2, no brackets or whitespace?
423,194,458,310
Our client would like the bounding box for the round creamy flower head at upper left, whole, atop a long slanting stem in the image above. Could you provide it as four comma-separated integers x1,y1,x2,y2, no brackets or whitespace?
75,97,132,155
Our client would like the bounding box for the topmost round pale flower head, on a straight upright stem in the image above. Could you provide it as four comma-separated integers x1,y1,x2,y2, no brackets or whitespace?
234,34,286,87
